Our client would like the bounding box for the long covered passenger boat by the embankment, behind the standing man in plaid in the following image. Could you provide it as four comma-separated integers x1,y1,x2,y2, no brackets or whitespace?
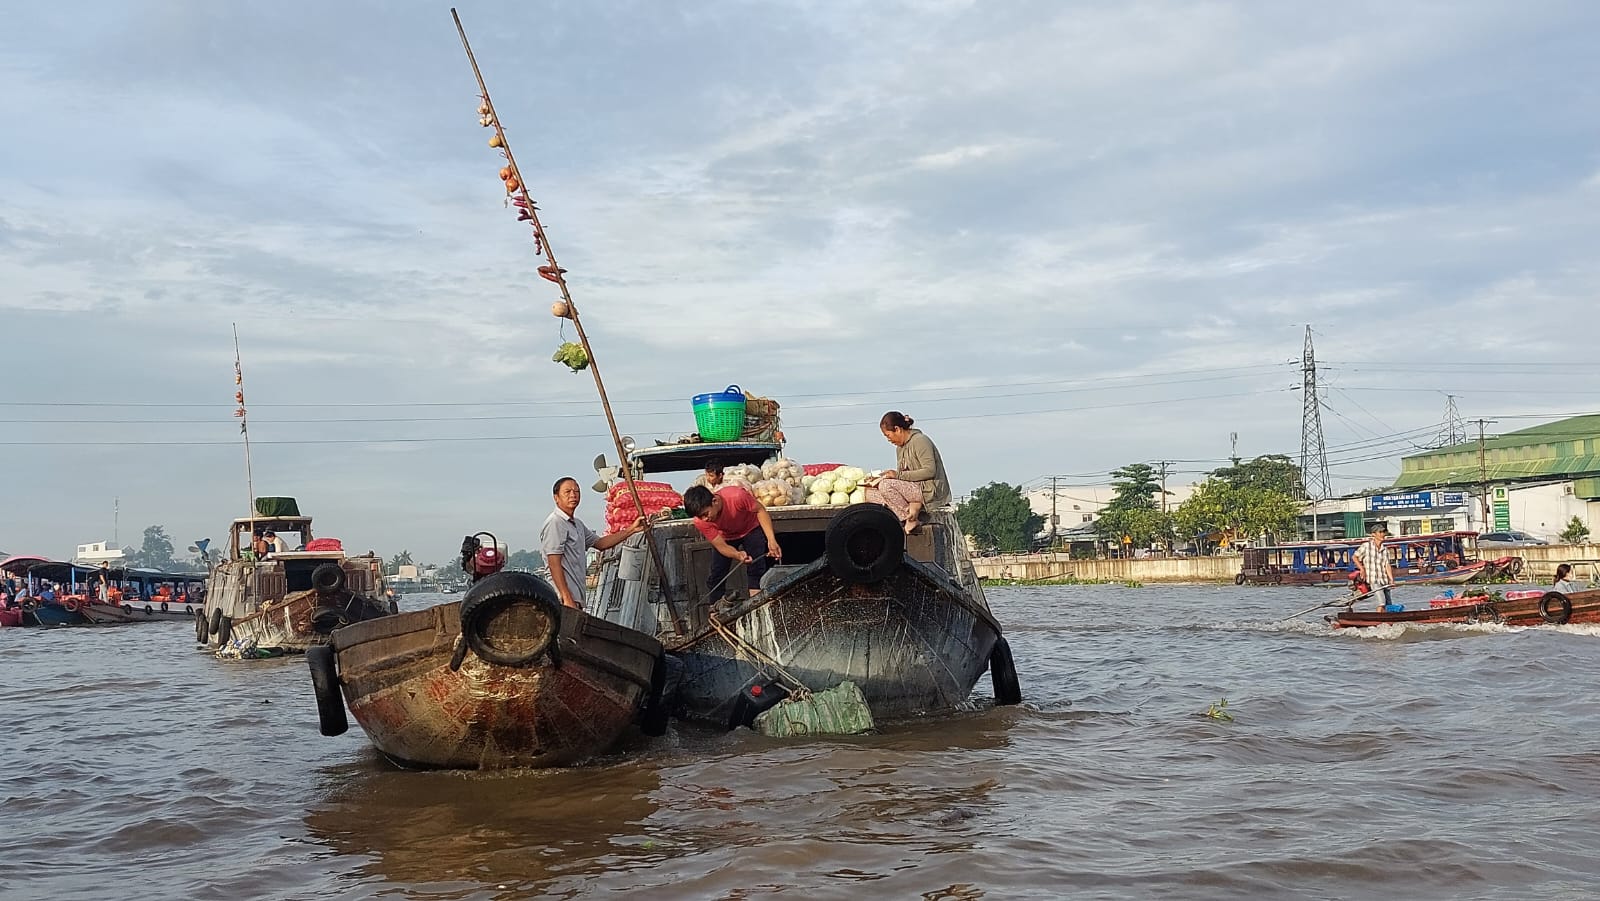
1234,531,1523,586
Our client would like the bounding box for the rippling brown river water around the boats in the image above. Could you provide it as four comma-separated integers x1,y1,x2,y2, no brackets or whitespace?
0,586,1600,901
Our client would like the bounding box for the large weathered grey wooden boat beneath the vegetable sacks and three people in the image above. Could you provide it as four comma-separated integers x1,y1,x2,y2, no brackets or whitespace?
590,442,1021,727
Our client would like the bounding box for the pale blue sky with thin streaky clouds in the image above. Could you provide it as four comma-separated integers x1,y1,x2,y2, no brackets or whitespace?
0,0,1600,560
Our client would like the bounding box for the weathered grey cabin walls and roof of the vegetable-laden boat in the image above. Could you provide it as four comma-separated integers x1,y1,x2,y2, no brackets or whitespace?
587,442,987,635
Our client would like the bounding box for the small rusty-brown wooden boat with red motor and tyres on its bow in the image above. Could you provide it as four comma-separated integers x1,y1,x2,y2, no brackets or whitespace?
306,533,667,770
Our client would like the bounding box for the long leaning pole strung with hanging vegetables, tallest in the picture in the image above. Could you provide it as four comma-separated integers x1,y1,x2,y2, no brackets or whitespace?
450,8,688,635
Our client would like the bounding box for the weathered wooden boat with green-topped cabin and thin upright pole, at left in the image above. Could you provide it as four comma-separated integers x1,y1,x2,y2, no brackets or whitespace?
195,498,397,656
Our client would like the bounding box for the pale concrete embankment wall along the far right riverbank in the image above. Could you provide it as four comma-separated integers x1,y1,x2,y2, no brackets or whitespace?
973,544,1600,584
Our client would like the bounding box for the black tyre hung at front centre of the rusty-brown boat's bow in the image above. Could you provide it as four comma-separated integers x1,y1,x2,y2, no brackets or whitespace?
461,571,565,667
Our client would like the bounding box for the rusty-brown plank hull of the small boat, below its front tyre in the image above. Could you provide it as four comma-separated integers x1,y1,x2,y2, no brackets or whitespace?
333,602,661,770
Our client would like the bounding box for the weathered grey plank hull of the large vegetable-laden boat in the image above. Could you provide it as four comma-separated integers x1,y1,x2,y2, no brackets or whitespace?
672,557,1000,725
